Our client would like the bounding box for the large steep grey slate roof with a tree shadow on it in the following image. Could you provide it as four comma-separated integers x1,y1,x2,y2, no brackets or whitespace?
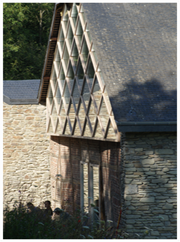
39,3,177,131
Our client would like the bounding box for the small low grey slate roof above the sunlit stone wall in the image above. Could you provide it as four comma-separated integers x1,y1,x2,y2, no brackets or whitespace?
3,79,40,104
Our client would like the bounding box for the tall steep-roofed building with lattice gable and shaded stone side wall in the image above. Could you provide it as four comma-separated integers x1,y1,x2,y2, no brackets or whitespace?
3,3,177,239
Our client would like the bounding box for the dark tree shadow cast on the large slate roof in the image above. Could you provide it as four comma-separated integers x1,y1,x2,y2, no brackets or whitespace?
110,77,177,122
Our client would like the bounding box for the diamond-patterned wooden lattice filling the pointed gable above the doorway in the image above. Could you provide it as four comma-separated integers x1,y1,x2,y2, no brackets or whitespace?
46,3,118,141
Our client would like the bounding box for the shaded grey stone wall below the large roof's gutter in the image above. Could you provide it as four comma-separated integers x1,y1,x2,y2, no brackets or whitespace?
123,133,177,239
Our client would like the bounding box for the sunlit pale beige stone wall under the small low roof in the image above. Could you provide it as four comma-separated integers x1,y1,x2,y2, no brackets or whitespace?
3,103,51,207
